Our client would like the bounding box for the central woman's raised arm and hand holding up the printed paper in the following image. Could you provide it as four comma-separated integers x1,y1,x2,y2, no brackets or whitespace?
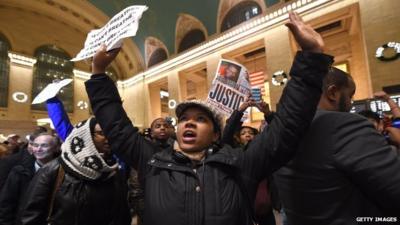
85,46,156,171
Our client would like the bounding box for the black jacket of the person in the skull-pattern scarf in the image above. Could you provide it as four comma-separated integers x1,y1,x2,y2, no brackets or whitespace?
20,159,130,225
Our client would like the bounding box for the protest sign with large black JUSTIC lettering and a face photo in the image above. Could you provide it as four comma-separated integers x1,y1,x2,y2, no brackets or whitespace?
207,60,251,117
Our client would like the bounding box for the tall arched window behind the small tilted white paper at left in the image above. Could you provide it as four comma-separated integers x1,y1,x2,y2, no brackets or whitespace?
32,45,74,112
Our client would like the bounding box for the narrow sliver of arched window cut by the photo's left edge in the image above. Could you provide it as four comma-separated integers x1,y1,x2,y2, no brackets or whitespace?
0,34,10,107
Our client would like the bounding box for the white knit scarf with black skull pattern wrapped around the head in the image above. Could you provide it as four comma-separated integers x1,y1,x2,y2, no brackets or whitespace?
61,118,118,180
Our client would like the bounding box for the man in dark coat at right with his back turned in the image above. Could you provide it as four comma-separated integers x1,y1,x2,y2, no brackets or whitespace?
276,68,400,225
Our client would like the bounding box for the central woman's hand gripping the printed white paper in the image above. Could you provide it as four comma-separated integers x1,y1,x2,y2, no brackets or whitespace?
92,44,121,74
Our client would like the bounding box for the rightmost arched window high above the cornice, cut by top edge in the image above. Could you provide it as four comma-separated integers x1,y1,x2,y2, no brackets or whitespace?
221,1,262,32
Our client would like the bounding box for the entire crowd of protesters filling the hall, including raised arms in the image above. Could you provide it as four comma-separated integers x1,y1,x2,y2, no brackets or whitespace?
0,13,400,225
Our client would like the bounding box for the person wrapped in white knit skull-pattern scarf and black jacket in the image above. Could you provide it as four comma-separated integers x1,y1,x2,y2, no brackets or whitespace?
18,118,131,225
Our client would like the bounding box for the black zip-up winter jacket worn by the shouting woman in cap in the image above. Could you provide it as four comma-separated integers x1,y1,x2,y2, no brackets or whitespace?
85,52,332,225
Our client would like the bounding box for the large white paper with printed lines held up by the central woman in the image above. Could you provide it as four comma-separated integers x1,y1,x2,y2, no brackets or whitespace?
71,5,148,61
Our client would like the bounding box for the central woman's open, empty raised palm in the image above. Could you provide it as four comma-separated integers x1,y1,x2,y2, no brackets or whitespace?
285,12,325,53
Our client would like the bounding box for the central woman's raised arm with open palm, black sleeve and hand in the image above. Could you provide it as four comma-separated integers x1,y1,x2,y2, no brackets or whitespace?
242,13,333,179
